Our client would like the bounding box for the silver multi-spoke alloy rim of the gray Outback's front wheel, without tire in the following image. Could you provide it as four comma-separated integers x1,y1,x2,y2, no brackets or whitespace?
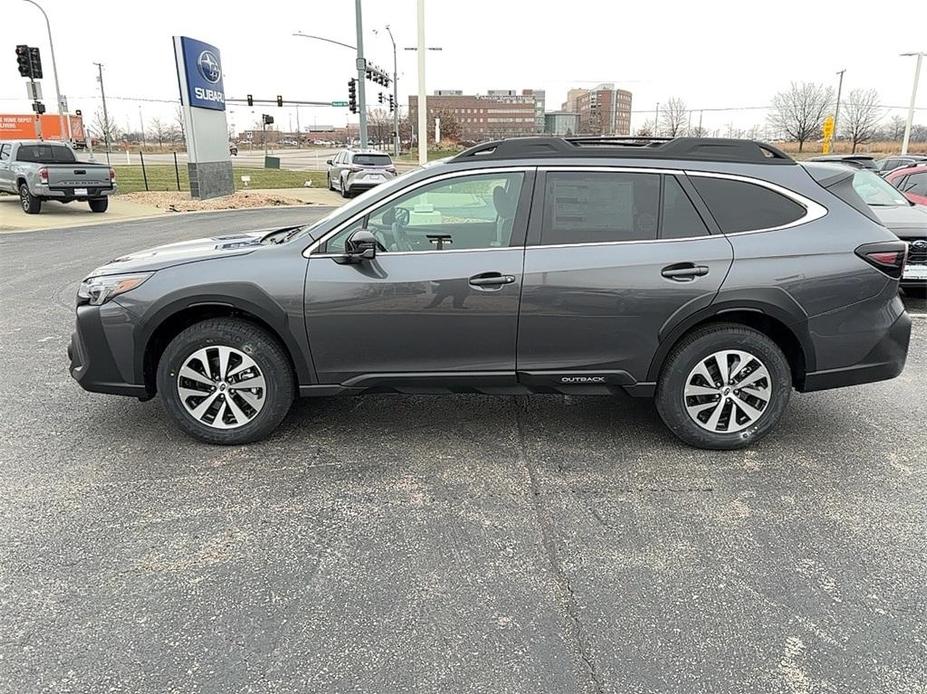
177,345,267,429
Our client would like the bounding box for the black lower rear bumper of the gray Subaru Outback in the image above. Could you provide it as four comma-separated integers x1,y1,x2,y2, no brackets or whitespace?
799,312,911,392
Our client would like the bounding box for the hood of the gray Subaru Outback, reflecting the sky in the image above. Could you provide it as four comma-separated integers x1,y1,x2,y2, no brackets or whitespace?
89,230,268,277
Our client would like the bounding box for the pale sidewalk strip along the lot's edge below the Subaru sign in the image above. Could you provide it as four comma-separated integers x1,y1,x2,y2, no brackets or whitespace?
0,188,344,234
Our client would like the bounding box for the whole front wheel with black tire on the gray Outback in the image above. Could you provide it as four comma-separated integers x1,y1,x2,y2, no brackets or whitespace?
157,318,296,445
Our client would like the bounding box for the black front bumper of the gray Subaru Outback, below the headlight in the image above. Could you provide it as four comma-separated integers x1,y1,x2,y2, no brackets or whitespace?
68,306,151,399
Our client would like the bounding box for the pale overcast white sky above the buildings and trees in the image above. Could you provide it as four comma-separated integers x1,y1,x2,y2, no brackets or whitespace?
0,0,927,135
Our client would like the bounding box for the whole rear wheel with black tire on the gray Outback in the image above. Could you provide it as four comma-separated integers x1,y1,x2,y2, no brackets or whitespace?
656,323,792,450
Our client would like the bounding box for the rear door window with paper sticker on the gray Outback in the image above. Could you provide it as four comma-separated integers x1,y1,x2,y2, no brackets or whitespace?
541,171,660,246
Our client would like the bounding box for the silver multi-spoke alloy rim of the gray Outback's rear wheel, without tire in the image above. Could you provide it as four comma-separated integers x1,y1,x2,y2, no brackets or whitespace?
683,350,772,434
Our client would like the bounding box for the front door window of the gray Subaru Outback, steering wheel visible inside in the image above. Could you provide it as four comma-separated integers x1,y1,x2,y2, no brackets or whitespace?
325,172,525,253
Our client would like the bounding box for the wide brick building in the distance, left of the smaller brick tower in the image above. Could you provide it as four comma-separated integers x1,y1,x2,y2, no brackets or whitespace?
409,90,544,142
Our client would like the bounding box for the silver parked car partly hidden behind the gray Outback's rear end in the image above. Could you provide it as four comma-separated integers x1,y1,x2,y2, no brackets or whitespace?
805,163,927,293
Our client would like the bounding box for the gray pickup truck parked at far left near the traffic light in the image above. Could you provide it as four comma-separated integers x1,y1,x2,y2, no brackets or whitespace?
0,140,116,214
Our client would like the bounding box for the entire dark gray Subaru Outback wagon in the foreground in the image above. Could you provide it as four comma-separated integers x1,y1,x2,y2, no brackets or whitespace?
69,137,911,449
